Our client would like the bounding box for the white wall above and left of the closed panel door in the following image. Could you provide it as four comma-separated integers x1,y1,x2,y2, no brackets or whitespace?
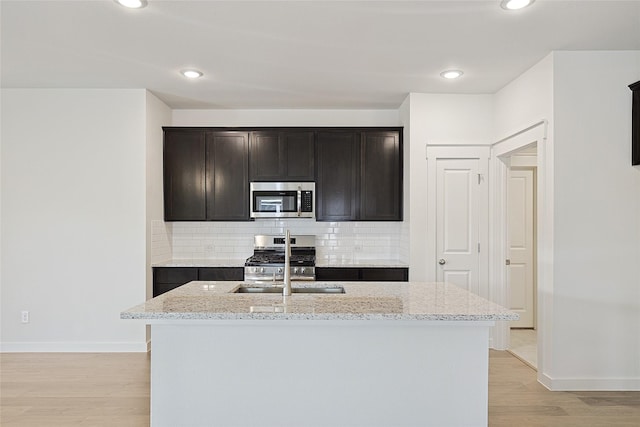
402,93,493,280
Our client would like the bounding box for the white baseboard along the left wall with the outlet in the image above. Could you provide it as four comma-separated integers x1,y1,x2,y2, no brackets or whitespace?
0,342,151,353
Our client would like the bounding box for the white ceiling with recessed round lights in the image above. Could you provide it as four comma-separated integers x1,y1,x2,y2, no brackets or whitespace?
0,0,640,109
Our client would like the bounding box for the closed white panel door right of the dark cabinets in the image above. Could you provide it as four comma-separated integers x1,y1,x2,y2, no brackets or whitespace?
436,159,480,294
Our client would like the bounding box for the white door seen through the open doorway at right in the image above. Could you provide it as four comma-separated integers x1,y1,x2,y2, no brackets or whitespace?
507,169,535,328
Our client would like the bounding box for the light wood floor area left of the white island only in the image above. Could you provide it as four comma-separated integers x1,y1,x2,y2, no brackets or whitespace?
0,353,150,427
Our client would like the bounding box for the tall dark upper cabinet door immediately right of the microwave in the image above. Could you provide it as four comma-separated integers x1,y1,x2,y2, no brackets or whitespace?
316,132,360,221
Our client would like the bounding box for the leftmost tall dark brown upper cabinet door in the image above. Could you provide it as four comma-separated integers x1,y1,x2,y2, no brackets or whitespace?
164,130,206,221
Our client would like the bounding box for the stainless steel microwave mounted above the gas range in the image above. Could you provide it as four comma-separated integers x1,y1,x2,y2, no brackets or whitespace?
249,182,316,218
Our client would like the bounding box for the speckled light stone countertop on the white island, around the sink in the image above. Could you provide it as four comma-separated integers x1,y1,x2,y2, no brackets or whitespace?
120,281,519,323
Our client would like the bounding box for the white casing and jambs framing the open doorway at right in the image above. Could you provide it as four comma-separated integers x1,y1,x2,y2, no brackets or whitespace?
489,120,554,387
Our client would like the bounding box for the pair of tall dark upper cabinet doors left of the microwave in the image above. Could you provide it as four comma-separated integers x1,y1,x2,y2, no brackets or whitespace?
164,128,249,221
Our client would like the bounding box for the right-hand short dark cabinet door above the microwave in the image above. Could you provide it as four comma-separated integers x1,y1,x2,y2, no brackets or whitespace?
280,131,315,181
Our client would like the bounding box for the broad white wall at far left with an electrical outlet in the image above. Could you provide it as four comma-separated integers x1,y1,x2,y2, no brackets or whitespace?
0,89,146,351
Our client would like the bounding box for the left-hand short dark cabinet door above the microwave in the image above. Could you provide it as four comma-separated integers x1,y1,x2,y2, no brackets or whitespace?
249,132,286,181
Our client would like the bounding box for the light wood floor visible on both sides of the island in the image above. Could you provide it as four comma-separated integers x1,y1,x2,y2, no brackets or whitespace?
0,351,640,427
